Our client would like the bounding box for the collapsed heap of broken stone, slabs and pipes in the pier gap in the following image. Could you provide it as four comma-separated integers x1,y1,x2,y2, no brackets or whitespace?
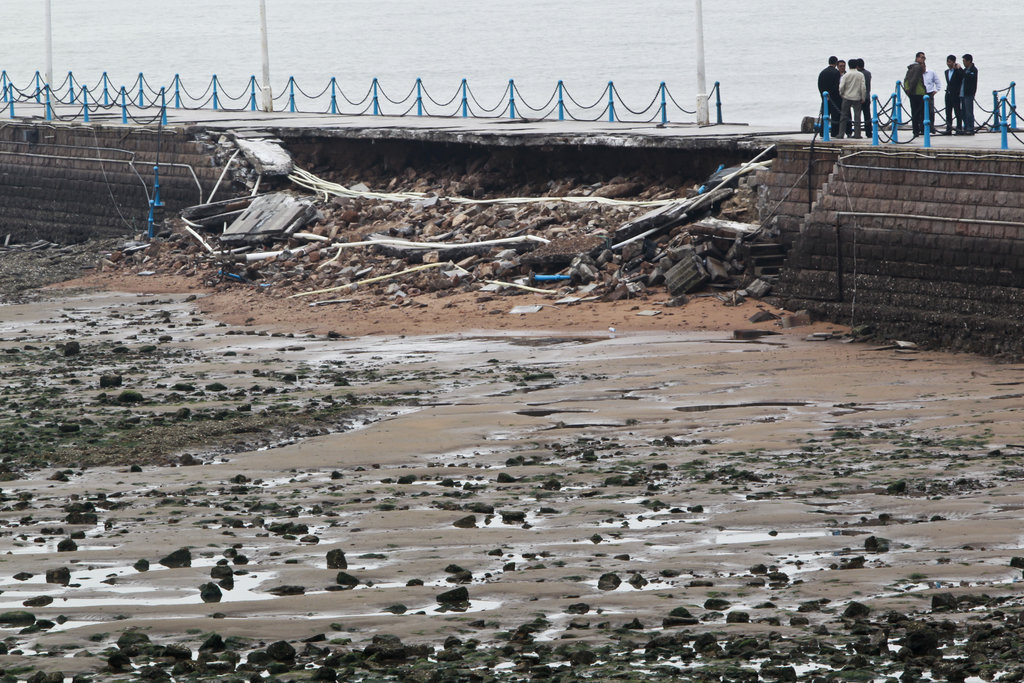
101,156,781,306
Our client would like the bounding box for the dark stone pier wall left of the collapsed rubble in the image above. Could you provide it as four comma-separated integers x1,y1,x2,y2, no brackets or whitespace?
0,123,227,244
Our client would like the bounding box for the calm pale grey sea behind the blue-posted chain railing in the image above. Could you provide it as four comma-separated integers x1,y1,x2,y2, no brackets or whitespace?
0,0,1024,129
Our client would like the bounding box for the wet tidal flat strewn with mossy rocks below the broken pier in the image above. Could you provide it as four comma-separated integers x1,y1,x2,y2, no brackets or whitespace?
0,295,1024,681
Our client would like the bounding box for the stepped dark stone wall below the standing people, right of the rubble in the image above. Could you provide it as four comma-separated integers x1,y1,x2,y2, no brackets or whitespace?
777,144,1024,356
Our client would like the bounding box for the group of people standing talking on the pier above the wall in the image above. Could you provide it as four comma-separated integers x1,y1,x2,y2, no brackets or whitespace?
818,52,978,138
